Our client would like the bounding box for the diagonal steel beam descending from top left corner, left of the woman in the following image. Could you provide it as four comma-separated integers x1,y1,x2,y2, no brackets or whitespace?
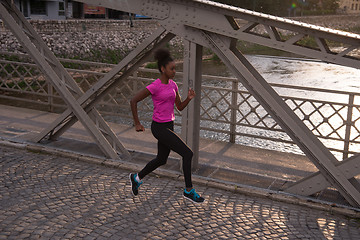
0,0,130,159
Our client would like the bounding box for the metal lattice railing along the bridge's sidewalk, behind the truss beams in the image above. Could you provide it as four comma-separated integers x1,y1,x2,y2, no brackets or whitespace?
0,52,360,160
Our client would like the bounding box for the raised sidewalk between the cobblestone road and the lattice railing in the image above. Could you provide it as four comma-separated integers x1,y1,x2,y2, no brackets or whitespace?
0,105,360,213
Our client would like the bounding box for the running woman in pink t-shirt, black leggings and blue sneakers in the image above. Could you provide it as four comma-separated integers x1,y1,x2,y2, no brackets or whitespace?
129,49,204,203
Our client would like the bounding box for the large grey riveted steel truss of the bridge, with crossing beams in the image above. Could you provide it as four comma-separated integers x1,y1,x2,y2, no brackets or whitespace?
0,0,360,207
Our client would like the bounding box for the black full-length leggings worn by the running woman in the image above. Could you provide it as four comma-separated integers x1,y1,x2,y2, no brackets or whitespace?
139,121,193,188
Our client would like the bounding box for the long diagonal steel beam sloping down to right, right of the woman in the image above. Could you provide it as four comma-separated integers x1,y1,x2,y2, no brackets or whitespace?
198,29,360,206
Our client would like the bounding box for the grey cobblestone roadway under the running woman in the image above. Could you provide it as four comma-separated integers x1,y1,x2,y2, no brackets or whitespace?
0,146,360,239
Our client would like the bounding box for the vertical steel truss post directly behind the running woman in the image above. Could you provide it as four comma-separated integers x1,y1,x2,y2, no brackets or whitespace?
181,41,202,169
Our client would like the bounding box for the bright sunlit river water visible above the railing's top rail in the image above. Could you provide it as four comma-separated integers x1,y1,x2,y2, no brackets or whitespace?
203,55,360,92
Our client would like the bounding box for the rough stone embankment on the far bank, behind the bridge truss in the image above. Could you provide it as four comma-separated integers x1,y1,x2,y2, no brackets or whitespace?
0,15,360,58
